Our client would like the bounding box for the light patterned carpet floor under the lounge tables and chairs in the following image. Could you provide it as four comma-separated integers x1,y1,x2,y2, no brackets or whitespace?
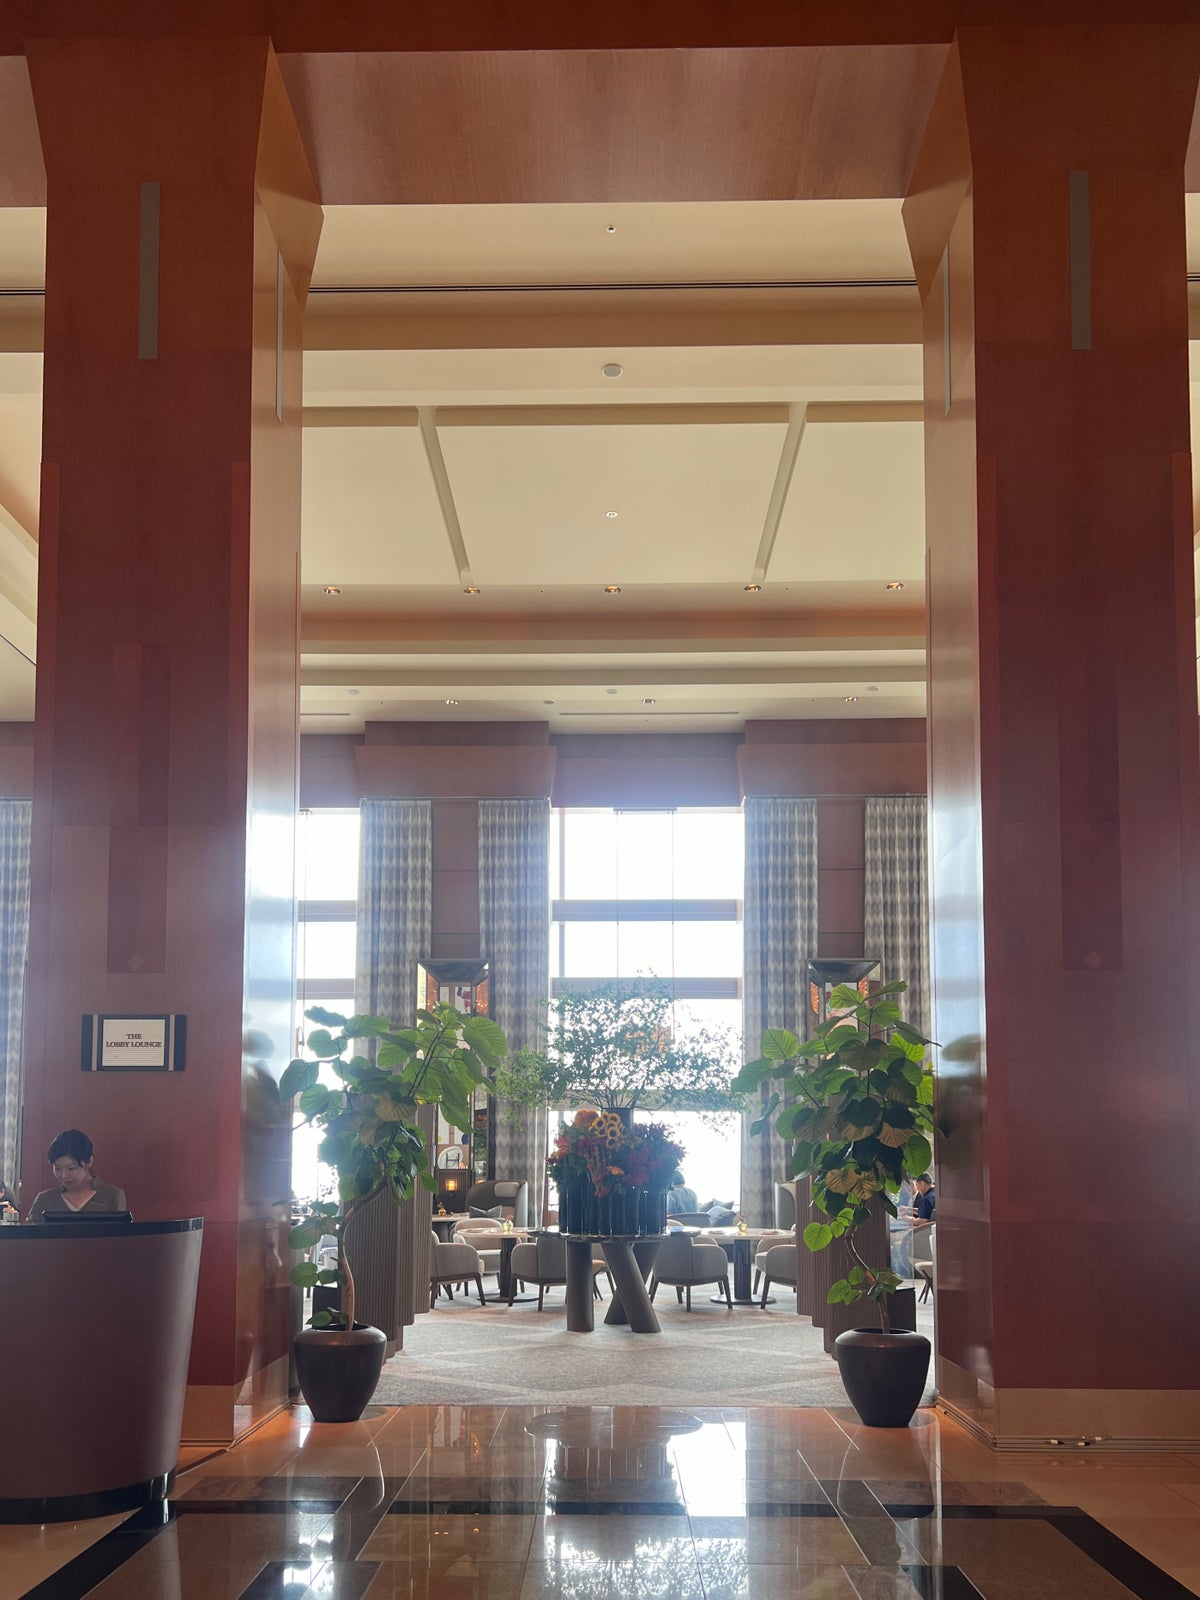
374,1290,933,1406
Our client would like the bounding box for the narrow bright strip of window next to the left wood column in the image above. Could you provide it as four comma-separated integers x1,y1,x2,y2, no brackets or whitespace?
291,811,358,1198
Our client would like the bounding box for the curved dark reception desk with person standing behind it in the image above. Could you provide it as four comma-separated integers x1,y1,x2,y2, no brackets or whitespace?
0,1216,203,1523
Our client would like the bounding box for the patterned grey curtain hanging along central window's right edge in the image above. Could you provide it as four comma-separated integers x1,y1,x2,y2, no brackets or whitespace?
741,797,818,1226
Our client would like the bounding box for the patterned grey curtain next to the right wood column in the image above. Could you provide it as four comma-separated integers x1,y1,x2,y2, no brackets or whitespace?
864,795,930,1034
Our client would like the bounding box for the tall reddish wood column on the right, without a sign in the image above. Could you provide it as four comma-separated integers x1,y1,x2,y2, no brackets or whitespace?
904,26,1200,1445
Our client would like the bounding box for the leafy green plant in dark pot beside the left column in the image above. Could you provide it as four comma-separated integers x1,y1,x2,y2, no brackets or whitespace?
278,1005,509,1422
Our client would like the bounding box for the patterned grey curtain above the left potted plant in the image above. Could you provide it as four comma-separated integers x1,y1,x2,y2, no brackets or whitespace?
354,800,434,1027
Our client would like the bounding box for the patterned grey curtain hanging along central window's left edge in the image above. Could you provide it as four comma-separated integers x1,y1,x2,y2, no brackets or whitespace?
478,800,550,1222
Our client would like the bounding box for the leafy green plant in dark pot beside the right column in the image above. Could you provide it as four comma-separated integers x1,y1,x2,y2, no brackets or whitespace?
734,982,933,1427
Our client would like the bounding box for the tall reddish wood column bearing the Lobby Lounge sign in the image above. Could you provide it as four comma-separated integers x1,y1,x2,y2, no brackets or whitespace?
24,38,320,1438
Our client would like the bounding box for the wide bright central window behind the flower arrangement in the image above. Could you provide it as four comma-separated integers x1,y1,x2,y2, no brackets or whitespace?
550,810,744,1203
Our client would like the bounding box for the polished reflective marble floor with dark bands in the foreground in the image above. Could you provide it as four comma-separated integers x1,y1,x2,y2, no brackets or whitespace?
0,1406,1200,1600
